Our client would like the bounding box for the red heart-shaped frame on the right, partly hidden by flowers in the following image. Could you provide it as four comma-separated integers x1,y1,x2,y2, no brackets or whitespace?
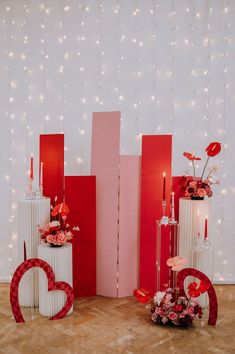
177,268,218,326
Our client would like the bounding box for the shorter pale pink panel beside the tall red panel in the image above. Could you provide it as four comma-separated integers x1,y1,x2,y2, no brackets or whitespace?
118,156,140,297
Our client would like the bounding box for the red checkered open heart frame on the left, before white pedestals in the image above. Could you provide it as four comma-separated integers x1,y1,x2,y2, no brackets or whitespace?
10,258,74,323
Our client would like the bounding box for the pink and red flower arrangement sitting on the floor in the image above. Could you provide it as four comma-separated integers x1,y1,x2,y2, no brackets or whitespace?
150,288,203,327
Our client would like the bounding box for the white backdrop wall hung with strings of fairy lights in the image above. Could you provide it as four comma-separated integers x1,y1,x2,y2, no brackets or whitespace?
0,0,235,282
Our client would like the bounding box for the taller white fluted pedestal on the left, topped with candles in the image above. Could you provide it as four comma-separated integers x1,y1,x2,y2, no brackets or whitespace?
17,198,50,307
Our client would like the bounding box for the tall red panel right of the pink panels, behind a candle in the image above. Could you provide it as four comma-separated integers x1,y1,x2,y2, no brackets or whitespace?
140,135,172,290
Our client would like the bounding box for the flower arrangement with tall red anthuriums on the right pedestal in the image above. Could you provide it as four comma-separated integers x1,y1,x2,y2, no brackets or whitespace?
180,142,221,199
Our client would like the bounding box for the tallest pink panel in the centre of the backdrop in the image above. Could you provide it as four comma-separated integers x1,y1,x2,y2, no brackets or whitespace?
91,112,121,297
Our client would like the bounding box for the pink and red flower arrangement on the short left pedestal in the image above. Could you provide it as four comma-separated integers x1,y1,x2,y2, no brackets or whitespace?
38,202,79,247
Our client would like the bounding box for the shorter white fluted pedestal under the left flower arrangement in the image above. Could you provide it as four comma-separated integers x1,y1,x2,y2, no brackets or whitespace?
38,243,73,317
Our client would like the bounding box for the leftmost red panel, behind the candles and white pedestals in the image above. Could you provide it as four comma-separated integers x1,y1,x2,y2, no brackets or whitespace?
40,134,64,203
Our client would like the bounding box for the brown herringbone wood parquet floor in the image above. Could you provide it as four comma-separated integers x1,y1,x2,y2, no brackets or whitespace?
0,284,235,354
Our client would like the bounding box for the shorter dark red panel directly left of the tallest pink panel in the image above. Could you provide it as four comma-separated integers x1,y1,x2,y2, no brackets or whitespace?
65,176,96,296
